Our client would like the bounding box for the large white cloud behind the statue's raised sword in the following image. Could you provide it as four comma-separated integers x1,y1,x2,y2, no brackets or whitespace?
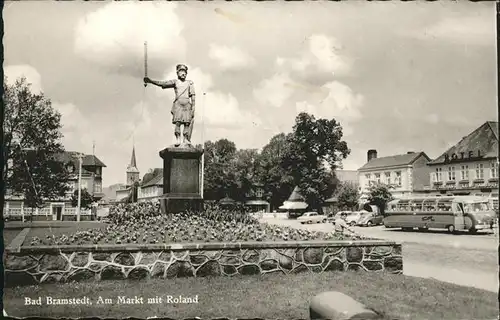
74,1,186,76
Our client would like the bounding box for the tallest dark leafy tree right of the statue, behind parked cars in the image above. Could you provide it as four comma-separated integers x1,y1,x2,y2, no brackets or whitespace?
282,112,350,209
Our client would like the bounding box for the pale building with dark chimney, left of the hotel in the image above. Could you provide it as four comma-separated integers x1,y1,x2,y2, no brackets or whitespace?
358,149,431,201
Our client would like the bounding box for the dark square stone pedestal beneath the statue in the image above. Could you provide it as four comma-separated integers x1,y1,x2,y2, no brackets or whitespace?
160,147,203,214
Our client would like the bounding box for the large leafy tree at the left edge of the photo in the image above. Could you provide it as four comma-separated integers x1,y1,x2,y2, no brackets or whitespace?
2,78,69,212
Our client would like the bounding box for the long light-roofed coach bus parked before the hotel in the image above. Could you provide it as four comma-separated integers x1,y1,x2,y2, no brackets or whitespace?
384,196,497,233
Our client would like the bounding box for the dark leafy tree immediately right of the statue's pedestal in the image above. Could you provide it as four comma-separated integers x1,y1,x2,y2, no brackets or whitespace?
203,139,237,200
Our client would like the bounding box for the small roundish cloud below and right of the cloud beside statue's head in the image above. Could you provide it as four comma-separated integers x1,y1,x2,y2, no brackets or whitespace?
253,73,293,108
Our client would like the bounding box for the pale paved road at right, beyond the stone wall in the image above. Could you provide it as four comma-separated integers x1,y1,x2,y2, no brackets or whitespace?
261,217,499,292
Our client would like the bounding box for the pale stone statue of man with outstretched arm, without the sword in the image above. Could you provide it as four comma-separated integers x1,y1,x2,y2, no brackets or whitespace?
144,64,196,147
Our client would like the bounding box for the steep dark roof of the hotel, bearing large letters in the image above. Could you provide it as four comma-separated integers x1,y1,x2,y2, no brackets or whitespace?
429,121,498,164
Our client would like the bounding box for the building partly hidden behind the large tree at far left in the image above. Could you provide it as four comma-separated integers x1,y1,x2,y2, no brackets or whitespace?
4,151,106,221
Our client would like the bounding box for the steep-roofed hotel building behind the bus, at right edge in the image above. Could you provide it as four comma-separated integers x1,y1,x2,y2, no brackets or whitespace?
419,121,498,208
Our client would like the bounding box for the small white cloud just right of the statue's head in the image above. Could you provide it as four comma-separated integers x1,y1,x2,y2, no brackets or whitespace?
208,44,255,70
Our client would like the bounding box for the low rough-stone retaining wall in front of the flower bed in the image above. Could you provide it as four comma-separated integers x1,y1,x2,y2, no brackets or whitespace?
4,240,403,286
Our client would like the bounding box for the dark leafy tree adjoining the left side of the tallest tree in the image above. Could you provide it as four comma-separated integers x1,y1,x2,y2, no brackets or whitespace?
257,133,295,209
